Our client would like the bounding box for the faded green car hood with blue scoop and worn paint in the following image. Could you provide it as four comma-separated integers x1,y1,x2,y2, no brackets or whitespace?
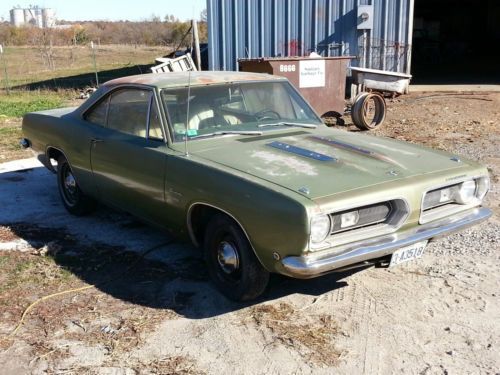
190,128,459,200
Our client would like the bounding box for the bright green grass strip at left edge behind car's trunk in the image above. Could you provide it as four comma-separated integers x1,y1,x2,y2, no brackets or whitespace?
0,91,65,117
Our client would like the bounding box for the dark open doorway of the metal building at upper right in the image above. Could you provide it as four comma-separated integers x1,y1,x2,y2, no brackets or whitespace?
412,0,500,84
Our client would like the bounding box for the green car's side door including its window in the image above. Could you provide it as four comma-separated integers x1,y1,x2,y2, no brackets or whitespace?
87,88,166,223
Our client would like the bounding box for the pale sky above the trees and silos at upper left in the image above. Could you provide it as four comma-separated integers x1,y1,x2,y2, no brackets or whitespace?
0,0,207,21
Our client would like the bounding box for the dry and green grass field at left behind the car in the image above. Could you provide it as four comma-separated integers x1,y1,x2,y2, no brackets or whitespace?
0,45,169,163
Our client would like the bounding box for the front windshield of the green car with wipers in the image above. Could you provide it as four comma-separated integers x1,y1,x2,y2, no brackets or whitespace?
161,82,322,142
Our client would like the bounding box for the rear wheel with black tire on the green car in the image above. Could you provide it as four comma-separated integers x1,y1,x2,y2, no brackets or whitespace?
57,155,95,216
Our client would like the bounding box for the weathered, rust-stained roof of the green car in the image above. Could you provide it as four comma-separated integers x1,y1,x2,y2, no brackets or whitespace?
103,71,286,89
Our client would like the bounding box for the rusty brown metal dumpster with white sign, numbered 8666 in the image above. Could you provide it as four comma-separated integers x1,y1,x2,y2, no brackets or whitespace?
238,56,353,116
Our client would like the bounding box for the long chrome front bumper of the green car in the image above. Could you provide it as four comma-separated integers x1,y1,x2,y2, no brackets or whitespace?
281,207,492,279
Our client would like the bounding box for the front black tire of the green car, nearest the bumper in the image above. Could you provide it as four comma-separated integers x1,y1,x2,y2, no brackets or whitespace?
204,214,269,301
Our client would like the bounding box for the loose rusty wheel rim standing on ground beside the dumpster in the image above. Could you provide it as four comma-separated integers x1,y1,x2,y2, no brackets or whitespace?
351,92,386,130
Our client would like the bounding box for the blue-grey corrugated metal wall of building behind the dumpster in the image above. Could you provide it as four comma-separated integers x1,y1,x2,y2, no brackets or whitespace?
207,0,414,72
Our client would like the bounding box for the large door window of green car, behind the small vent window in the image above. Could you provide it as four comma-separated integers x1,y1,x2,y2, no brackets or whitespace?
107,89,151,138
